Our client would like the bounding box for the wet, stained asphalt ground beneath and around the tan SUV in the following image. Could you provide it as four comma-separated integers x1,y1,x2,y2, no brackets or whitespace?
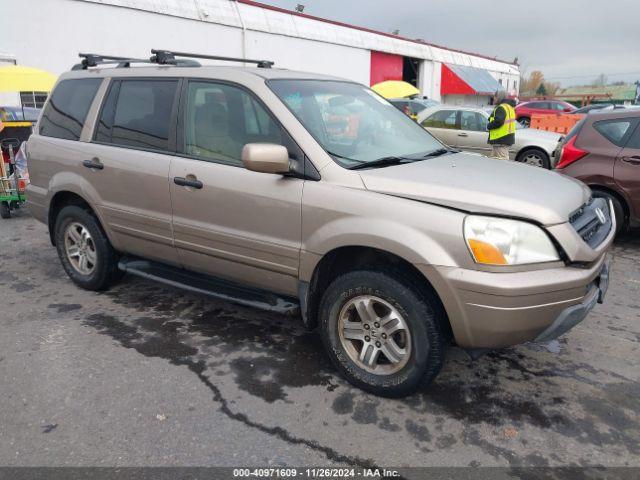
0,213,640,467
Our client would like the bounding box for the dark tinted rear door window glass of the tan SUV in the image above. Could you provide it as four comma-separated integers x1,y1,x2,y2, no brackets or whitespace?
95,80,178,150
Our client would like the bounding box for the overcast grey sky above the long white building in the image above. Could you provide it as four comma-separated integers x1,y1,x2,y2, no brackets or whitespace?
262,0,640,85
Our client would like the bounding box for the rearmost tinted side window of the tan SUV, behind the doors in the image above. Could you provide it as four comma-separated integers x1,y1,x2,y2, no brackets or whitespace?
40,78,102,140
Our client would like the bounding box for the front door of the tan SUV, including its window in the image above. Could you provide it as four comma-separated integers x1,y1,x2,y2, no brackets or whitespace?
169,80,304,295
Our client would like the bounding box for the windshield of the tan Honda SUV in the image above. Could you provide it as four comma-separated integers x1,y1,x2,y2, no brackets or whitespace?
268,80,442,168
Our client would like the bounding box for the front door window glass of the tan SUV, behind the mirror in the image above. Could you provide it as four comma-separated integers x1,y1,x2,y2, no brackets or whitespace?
184,81,291,166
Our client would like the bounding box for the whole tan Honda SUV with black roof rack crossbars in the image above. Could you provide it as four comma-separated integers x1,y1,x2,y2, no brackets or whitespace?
27,51,615,396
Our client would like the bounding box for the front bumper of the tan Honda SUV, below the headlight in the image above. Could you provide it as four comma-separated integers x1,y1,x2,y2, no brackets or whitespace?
423,255,609,349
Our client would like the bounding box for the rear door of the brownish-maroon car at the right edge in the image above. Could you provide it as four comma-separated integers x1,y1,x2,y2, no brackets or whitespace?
614,119,640,220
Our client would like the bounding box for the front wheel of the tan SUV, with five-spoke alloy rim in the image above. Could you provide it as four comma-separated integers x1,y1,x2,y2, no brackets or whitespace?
319,270,445,397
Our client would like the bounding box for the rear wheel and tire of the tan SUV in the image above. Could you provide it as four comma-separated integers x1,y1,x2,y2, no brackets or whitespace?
54,205,122,291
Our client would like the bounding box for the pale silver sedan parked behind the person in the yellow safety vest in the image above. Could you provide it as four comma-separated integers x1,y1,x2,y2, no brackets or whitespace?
418,105,562,168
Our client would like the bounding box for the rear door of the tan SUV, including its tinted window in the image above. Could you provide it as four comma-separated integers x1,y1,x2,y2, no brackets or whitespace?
89,78,179,264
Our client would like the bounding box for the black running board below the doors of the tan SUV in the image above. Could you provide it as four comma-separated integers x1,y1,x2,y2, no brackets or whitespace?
118,257,300,315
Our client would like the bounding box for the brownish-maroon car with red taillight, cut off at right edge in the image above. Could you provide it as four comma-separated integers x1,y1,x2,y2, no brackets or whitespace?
555,109,640,236
